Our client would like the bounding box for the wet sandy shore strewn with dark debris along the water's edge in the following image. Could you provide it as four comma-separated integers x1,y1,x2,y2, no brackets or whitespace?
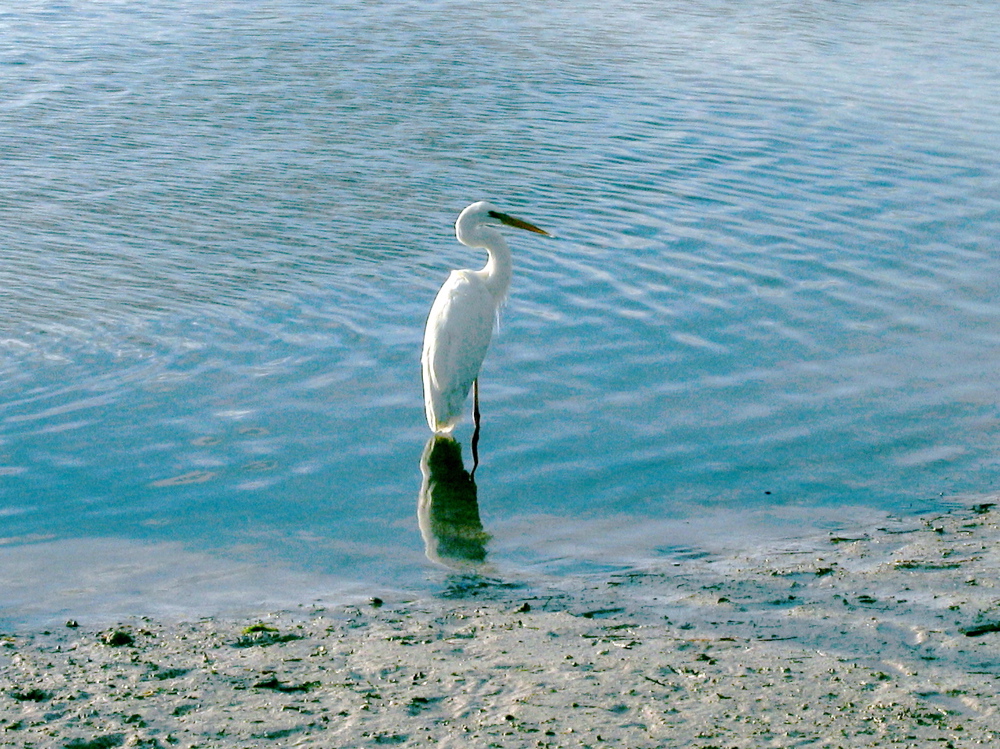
0,500,1000,749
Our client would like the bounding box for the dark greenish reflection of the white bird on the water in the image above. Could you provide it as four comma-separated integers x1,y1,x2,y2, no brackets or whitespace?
417,434,490,570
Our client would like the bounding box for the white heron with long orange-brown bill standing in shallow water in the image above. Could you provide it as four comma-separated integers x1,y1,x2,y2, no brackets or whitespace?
420,202,551,442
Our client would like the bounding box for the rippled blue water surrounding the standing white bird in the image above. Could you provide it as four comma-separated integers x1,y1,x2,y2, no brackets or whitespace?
0,0,1000,618
